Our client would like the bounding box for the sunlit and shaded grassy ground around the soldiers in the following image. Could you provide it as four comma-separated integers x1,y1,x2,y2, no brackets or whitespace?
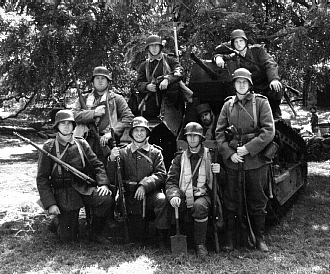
0,104,330,274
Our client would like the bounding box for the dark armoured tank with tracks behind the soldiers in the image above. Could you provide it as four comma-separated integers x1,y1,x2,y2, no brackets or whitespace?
150,54,307,222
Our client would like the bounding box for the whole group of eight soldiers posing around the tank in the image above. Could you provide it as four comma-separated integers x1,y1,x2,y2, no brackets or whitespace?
37,30,281,257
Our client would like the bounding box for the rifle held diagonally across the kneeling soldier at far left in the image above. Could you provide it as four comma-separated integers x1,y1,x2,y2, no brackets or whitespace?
13,131,96,184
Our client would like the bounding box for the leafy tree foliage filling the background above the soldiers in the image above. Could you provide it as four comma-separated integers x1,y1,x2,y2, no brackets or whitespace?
0,0,330,119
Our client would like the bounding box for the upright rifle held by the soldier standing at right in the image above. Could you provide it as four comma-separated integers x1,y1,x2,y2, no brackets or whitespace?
237,129,256,246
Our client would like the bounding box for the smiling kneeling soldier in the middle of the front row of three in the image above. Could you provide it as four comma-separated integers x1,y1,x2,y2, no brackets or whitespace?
107,116,170,248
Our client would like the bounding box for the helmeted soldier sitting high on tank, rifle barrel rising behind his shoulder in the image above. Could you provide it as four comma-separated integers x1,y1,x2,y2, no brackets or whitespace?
137,35,183,119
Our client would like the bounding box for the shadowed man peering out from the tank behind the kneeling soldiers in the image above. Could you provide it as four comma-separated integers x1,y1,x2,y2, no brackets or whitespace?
196,103,218,140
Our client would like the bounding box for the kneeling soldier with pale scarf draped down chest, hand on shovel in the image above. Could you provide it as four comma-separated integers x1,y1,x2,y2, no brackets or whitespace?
166,122,220,257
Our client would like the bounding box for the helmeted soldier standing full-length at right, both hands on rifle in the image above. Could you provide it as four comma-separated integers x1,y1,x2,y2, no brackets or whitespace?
215,68,275,252
